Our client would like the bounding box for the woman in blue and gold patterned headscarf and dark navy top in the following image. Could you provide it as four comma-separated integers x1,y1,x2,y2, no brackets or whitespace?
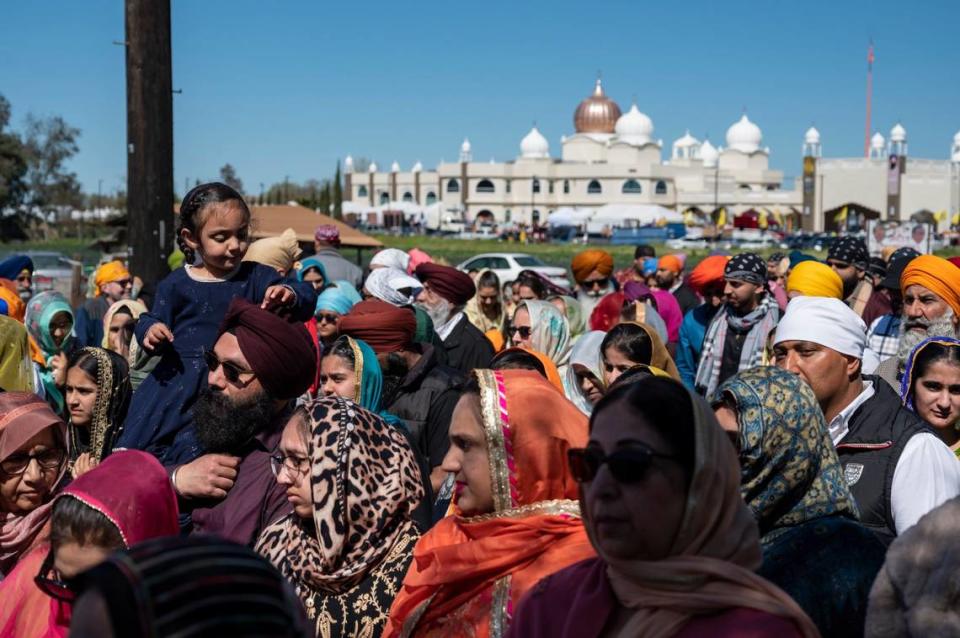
713,366,885,636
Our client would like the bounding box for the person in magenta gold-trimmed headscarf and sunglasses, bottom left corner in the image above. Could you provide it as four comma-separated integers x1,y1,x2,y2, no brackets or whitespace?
0,450,180,638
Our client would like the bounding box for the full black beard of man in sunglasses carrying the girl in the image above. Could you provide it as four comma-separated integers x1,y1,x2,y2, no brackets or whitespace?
193,388,276,454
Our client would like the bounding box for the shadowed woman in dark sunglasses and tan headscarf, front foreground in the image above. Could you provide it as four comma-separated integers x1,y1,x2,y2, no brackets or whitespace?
508,378,817,638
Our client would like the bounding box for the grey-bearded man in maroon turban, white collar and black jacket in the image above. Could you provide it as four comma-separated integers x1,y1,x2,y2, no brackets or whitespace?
415,264,494,374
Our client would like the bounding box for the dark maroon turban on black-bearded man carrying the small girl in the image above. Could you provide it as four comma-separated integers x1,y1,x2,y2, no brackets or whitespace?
220,297,317,399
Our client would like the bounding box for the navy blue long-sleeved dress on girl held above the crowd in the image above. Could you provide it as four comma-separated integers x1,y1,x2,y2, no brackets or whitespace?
116,262,317,466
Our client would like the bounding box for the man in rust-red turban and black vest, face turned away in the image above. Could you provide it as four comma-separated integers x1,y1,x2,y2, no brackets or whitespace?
340,299,464,494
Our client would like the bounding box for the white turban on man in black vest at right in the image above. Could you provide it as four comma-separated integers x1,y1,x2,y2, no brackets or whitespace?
774,297,867,359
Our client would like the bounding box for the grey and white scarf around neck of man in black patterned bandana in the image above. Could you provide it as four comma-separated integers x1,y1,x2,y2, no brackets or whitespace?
696,295,780,396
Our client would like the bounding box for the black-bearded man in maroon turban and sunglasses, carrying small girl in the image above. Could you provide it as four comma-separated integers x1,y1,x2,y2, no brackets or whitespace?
171,297,317,545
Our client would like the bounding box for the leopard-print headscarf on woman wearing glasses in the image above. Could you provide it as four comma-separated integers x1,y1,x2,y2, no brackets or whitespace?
257,397,424,602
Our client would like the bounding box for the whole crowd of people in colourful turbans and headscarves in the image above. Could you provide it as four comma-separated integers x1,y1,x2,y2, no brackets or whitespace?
0,183,960,638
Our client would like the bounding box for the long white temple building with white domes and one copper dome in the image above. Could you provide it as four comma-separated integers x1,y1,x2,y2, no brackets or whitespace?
344,79,960,231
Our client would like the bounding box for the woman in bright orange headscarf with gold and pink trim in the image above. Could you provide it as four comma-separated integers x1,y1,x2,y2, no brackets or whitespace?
384,370,593,638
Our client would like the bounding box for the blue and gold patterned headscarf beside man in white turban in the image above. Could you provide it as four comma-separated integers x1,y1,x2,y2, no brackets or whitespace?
713,366,858,543
